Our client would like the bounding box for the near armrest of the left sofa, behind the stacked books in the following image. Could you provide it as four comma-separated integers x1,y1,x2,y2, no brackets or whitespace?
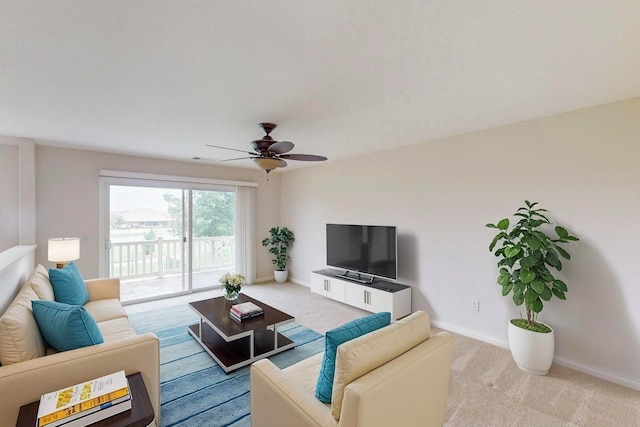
0,333,160,425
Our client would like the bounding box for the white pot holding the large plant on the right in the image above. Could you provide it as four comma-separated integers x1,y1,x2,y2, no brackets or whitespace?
509,322,554,375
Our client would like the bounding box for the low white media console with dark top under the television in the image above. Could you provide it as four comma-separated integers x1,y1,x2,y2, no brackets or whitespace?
311,269,411,319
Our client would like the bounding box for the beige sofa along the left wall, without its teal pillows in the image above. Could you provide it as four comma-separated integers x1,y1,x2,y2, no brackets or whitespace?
0,265,160,425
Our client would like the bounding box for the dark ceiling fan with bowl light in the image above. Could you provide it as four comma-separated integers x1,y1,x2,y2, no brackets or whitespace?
206,122,327,174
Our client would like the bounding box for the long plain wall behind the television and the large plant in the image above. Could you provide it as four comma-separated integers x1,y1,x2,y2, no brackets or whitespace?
280,98,640,389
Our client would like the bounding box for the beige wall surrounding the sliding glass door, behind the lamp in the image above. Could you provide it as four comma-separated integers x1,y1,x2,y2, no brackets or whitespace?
36,145,280,278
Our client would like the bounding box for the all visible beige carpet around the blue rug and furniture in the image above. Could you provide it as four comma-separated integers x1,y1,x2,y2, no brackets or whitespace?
127,283,640,427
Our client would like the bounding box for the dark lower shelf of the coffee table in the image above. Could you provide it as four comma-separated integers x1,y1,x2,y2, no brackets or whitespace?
188,322,295,373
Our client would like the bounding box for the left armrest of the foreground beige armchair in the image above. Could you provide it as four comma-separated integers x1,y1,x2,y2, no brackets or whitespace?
251,359,338,427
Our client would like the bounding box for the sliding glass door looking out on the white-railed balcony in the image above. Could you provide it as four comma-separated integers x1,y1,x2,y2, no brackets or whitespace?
102,179,236,302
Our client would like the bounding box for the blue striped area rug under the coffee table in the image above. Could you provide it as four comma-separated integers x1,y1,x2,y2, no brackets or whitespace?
129,305,324,427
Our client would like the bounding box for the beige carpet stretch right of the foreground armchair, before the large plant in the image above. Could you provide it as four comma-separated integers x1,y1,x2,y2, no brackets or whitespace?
445,336,640,427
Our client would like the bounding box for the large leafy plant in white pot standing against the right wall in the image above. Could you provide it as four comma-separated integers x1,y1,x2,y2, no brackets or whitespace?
486,200,579,375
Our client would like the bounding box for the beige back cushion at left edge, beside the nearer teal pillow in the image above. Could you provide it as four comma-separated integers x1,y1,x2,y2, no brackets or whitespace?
0,283,46,366
